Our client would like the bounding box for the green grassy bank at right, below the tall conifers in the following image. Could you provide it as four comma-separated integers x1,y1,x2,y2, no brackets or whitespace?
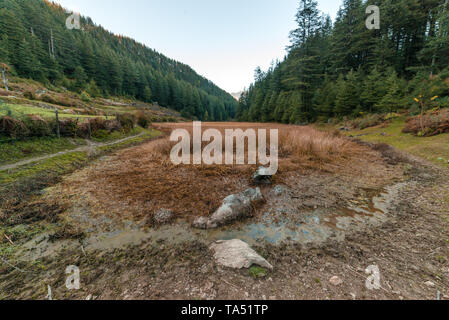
348,117,449,168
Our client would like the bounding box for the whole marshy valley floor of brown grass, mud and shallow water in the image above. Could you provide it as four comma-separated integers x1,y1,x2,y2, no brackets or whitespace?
0,123,449,299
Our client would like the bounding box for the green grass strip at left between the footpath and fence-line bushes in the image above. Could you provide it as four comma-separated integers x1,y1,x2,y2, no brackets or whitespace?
0,137,86,165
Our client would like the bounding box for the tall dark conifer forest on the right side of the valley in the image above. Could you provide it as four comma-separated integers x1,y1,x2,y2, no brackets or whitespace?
236,0,449,124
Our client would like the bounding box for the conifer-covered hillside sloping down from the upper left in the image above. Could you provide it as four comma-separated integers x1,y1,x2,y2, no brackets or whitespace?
0,0,237,120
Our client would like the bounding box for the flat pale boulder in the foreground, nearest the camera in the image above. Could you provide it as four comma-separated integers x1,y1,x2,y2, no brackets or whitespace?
210,239,273,270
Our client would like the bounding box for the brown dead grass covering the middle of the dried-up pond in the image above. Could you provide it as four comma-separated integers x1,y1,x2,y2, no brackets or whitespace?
54,123,383,218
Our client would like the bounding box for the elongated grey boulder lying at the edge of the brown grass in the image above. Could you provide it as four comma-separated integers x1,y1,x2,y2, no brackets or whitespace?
192,188,264,229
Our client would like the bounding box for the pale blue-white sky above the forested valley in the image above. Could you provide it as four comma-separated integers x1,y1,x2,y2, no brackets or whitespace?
54,0,342,93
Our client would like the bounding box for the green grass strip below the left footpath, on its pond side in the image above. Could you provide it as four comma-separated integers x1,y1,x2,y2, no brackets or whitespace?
0,152,88,184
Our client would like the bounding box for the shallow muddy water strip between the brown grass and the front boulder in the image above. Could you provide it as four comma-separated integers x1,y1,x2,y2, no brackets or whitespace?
86,183,405,250
